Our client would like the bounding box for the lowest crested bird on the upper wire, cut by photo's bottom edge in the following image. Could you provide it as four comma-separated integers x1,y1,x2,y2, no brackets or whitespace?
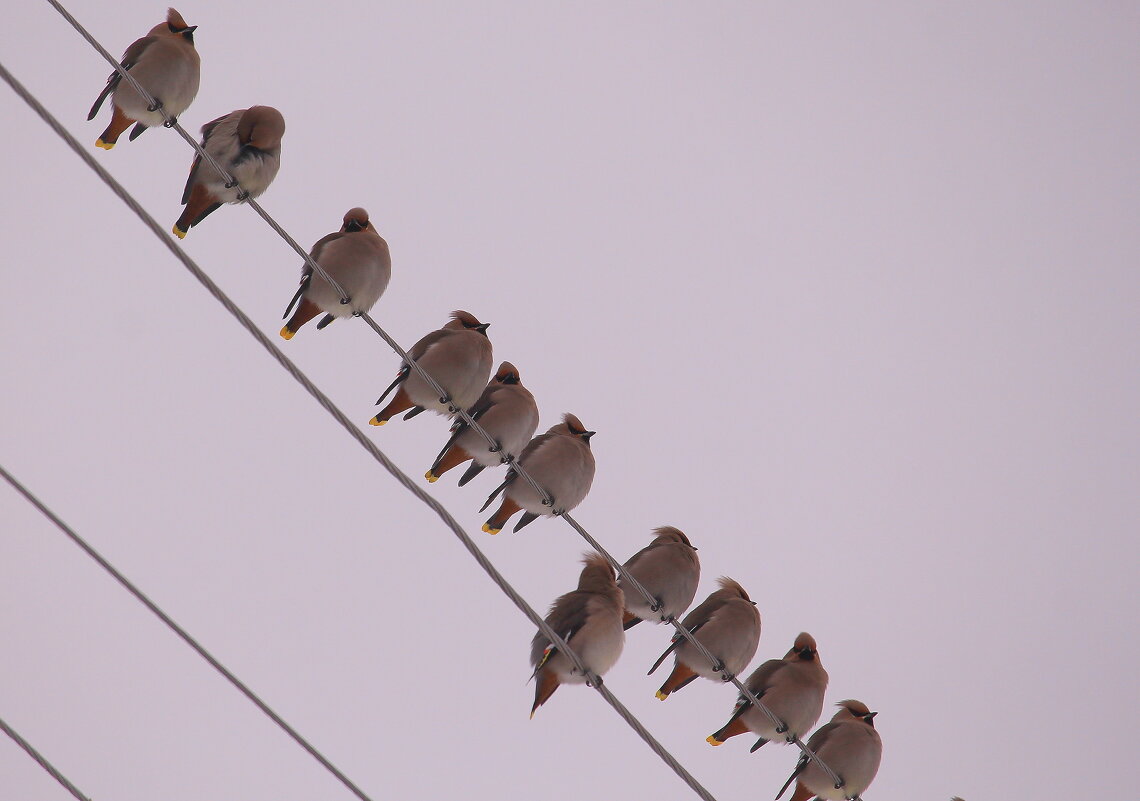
776,700,882,801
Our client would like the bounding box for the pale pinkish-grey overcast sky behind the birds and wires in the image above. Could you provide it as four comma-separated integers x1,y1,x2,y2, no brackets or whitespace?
0,0,1140,801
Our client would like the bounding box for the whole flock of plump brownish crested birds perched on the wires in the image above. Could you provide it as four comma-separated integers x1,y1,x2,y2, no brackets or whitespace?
73,8,960,801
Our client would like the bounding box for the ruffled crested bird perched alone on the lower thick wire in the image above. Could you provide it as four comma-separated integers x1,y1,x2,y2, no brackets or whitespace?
530,554,626,718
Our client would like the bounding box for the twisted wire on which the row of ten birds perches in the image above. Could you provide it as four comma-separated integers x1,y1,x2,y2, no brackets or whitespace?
47,6,858,801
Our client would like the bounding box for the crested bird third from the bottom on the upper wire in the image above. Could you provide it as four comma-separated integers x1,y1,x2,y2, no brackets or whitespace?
649,575,760,701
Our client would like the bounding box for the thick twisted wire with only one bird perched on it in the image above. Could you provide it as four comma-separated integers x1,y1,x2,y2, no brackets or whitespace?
0,60,715,801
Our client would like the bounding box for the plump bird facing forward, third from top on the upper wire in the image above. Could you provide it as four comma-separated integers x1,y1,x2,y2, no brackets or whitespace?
280,206,392,340
